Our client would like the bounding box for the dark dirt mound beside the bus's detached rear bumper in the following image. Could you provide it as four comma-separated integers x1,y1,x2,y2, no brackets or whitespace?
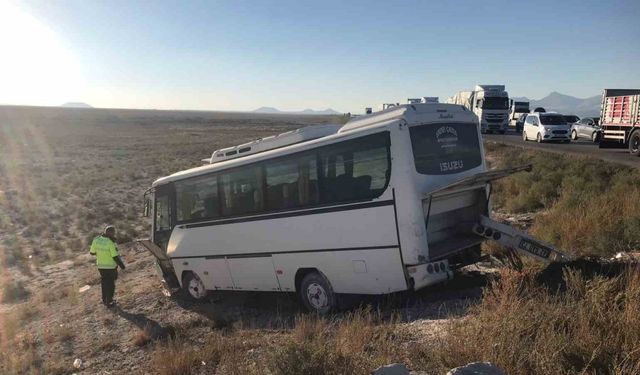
535,257,640,292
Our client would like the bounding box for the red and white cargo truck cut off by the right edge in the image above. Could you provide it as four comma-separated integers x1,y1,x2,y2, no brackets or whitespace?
599,89,640,156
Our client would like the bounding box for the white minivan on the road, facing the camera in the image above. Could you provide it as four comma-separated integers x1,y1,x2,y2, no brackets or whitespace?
522,112,571,143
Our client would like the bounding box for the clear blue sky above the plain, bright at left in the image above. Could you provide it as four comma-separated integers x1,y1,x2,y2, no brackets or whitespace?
0,0,640,112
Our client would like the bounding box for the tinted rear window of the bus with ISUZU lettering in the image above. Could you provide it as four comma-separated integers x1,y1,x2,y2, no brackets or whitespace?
409,123,482,175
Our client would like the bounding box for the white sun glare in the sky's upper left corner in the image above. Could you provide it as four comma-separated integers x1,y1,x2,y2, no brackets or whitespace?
0,0,82,105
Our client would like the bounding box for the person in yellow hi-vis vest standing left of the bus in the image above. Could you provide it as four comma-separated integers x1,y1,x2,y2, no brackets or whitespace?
89,225,125,307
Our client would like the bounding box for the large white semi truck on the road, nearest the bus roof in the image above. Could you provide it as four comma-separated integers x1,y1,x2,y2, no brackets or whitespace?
447,85,509,134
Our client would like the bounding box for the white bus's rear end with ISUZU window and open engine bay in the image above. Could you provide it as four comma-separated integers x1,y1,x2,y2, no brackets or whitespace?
397,105,489,290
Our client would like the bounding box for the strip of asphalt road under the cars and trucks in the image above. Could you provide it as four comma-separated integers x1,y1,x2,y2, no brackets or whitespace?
482,130,640,169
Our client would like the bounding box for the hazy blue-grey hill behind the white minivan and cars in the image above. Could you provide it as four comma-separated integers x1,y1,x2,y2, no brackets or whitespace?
511,91,602,117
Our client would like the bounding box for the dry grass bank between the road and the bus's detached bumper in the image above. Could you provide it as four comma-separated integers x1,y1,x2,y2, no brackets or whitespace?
487,144,640,256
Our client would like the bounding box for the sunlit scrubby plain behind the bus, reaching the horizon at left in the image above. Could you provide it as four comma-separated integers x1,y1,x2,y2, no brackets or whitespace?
0,106,345,270
